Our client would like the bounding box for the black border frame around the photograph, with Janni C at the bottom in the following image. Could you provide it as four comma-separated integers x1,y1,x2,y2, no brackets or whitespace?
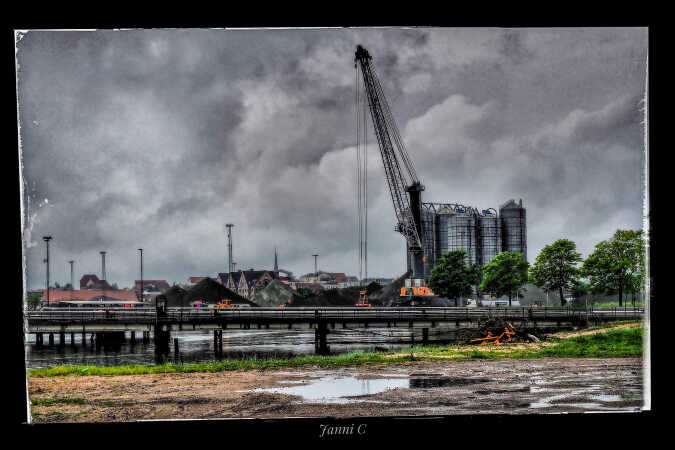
3,14,667,447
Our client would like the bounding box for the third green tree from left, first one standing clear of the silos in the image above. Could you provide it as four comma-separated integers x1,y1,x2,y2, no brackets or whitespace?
530,239,582,306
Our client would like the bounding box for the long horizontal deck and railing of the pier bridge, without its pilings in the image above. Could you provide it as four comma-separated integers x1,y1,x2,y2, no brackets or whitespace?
25,307,644,333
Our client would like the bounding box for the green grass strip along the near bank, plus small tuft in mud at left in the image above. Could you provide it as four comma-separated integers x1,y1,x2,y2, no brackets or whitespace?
28,322,642,378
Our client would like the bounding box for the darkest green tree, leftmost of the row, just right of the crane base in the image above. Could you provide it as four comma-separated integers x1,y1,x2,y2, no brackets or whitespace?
429,249,480,306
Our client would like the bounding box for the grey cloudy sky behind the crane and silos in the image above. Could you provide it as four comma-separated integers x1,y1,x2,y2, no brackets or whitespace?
17,28,648,288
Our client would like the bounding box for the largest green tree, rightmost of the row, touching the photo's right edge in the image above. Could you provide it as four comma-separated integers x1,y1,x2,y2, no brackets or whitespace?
582,230,645,306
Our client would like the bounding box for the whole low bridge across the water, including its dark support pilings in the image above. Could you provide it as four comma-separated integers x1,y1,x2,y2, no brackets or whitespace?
25,307,644,353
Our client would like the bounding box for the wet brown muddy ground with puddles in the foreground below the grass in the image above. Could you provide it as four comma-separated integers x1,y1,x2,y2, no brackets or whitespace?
29,358,642,423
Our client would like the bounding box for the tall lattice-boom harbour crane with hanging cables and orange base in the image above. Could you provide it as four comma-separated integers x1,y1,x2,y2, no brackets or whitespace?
354,45,433,297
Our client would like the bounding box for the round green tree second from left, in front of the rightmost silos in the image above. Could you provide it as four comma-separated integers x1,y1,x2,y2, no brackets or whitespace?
479,252,530,306
